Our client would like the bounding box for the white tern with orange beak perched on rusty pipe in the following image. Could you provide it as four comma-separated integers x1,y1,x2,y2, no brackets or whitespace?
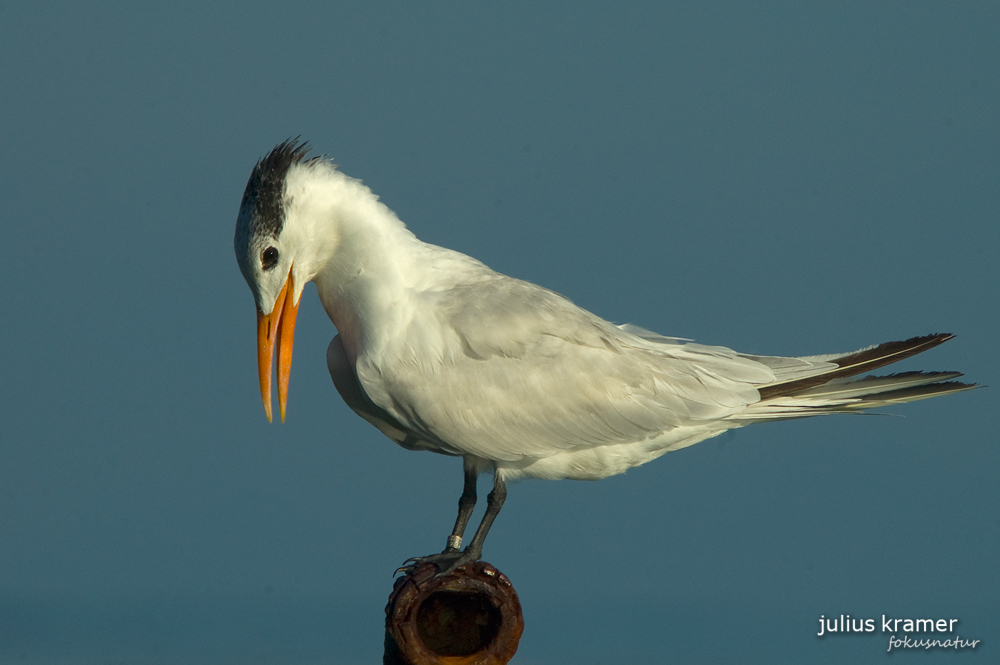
235,140,976,574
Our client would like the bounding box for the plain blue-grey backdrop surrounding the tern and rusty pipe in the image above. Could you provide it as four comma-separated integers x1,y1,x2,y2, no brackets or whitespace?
0,2,1000,665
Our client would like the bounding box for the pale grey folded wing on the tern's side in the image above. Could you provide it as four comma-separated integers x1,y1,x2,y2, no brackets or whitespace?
352,275,775,461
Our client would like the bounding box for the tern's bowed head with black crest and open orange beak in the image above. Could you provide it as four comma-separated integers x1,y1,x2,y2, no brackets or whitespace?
234,139,319,422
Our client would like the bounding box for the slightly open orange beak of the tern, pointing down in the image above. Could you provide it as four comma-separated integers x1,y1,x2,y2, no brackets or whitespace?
257,271,299,422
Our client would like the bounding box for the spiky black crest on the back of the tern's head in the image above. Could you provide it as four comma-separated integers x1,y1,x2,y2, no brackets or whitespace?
240,137,317,238
